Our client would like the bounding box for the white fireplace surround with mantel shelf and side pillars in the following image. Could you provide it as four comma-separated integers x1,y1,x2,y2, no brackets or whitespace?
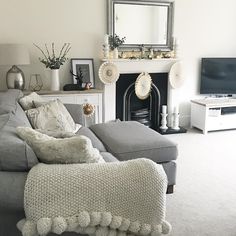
103,58,179,122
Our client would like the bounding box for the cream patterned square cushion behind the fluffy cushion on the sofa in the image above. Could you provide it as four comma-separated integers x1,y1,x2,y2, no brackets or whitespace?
26,100,81,133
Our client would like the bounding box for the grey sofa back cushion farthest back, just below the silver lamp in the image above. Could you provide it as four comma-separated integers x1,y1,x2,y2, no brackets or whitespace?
0,89,23,115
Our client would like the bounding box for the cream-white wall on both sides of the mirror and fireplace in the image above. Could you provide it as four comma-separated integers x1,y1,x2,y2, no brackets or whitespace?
0,0,236,123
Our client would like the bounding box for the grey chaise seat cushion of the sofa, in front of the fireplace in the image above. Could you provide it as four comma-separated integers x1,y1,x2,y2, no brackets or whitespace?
90,121,177,163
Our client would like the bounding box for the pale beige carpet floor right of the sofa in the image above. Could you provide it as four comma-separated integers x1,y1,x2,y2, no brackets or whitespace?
166,130,236,236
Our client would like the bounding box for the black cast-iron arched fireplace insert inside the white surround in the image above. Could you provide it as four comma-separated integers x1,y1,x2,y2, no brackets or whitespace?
116,73,168,130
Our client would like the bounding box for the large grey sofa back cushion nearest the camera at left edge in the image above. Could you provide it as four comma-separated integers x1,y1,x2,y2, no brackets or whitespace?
0,109,38,171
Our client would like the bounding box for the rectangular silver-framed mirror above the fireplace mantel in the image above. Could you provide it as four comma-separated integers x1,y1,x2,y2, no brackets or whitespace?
108,0,173,49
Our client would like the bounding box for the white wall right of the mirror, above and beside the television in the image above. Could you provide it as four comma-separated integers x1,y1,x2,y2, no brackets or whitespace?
174,0,236,124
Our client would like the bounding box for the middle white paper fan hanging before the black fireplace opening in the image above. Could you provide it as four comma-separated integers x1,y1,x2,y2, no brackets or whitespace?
135,72,152,100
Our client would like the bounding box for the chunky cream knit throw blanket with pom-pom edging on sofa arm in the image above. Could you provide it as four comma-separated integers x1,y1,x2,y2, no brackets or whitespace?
17,159,171,236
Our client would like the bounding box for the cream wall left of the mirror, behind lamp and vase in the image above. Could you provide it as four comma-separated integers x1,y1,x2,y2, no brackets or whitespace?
0,0,106,89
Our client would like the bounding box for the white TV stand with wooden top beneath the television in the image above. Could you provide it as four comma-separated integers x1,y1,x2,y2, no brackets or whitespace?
191,98,236,134
